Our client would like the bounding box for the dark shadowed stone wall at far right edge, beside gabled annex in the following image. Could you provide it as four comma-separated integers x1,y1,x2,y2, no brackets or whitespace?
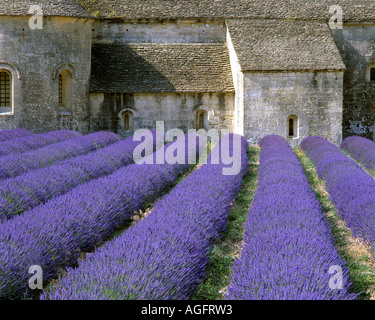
332,23,375,139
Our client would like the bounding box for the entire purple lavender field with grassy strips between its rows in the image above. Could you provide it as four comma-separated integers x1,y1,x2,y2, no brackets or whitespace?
0,129,375,300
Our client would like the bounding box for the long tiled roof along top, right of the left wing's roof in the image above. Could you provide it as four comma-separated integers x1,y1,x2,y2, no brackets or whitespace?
77,0,375,21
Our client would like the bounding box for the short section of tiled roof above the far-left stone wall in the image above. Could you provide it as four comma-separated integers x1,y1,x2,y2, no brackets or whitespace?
0,0,93,18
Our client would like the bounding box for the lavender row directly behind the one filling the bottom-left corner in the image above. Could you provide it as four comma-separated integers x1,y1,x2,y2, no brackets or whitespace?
0,130,156,221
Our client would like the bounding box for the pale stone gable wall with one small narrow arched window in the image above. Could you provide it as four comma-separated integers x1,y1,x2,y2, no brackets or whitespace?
244,72,343,146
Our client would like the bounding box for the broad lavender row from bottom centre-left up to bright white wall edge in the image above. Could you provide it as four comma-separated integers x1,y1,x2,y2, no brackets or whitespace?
41,132,248,300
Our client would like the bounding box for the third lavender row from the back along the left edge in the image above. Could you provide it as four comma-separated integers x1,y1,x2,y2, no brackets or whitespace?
0,132,120,182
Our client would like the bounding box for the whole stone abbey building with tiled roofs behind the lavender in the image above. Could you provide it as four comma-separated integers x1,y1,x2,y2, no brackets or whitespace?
0,0,375,144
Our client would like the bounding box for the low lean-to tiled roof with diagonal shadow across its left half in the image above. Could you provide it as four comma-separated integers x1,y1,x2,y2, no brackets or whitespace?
91,44,234,93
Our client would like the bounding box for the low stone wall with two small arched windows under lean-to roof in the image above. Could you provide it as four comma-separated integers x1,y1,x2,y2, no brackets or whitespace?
90,93,234,133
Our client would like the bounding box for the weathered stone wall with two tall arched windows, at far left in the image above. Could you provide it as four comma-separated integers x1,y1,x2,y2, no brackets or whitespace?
0,16,92,133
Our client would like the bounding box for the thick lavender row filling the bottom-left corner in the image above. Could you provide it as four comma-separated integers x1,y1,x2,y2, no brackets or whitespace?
0,133,203,299
